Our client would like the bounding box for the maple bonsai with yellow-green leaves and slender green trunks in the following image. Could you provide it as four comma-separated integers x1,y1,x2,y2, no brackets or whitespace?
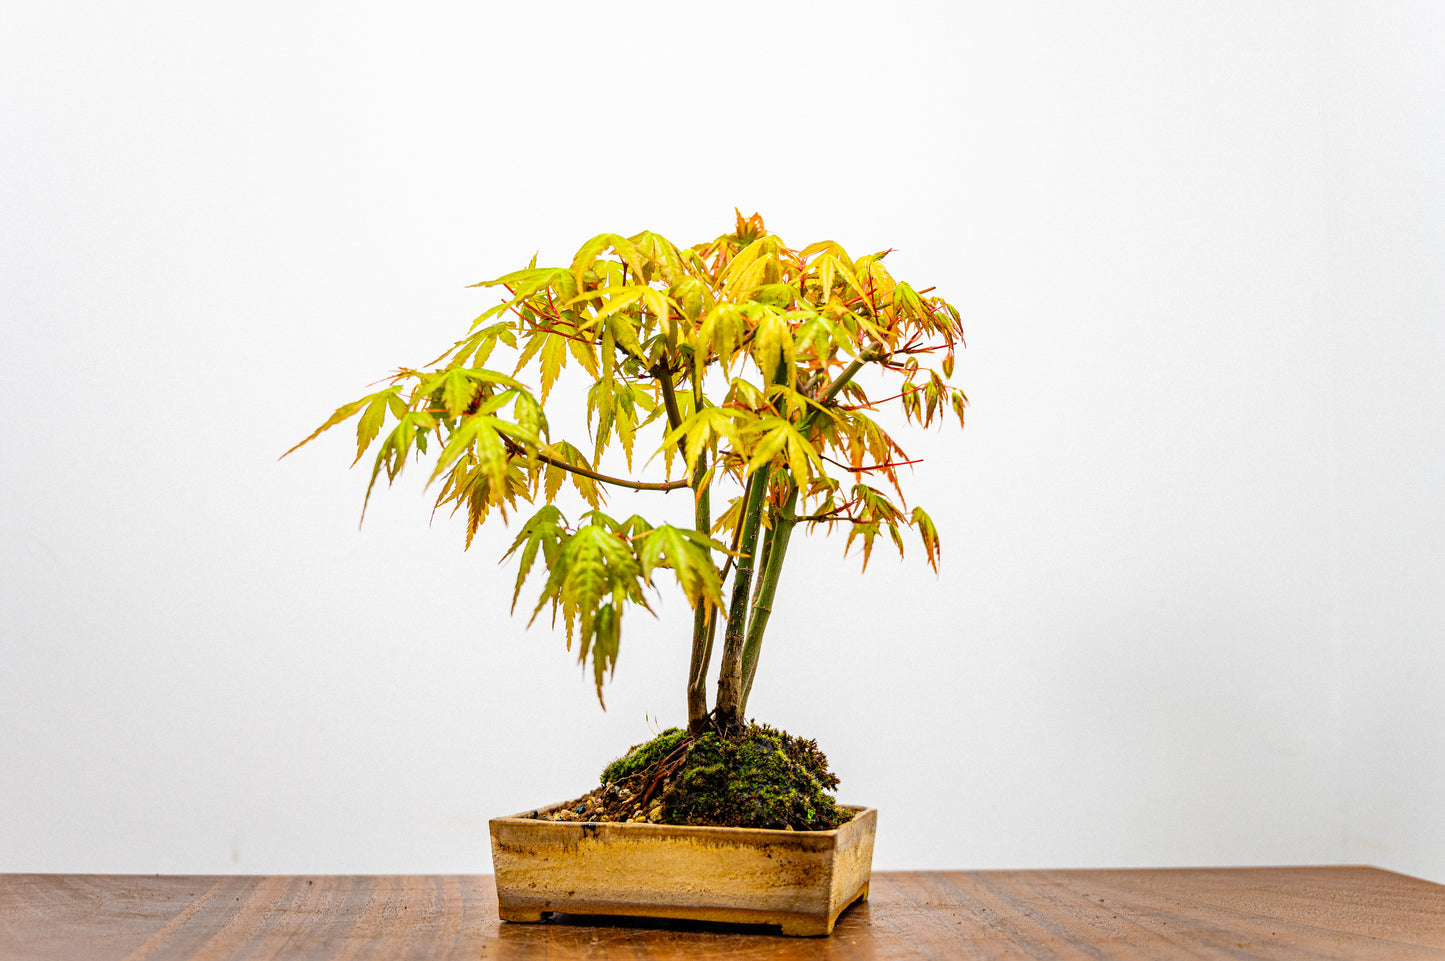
283,212,967,736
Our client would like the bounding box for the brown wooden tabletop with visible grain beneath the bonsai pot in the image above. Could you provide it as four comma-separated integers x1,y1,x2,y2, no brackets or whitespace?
0,867,1445,961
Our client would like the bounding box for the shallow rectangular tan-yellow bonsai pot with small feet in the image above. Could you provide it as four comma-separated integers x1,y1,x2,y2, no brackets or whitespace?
490,805,877,935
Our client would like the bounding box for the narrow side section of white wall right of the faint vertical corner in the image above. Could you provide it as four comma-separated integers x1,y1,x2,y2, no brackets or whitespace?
1327,4,1445,882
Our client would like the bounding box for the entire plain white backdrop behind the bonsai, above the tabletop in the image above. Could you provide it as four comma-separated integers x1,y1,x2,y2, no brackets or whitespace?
0,0,1445,882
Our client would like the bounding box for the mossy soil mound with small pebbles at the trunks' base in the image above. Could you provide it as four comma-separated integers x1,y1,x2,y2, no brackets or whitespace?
539,724,853,831
